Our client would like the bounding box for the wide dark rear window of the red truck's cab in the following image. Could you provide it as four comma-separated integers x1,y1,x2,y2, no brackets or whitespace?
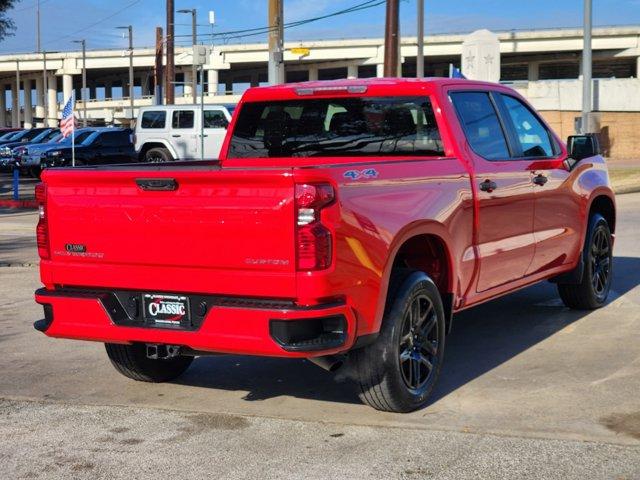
229,97,444,158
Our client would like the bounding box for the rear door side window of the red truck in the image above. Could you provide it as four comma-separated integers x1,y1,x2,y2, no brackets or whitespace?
451,92,509,160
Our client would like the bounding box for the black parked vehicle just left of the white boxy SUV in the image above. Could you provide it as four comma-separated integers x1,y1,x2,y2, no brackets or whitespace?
41,127,138,168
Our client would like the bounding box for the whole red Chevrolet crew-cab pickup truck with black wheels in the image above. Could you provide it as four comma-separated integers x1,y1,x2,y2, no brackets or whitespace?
35,79,615,412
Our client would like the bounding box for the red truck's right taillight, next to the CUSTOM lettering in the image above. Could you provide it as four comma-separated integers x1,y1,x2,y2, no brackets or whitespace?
295,183,335,270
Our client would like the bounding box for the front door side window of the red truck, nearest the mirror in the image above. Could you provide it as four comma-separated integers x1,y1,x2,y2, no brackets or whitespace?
501,95,554,157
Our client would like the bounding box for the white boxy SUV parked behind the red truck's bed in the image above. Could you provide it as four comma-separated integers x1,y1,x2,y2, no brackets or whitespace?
134,105,231,162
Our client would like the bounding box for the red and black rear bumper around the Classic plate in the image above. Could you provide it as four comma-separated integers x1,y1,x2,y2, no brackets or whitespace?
34,288,356,357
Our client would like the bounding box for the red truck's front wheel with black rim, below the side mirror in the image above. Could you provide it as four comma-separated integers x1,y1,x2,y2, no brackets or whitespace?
558,213,613,310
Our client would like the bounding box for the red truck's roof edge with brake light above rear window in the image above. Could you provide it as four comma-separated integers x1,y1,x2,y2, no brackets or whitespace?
243,77,498,101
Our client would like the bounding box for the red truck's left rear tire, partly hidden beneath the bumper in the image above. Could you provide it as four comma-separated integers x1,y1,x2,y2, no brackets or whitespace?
104,343,193,383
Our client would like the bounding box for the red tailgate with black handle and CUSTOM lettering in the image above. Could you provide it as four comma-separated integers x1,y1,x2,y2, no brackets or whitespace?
42,166,295,297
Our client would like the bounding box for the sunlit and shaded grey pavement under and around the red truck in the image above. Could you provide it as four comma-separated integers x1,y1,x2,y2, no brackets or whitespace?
0,194,640,480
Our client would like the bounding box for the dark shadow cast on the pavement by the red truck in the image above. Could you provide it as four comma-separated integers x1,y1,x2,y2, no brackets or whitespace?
175,257,640,403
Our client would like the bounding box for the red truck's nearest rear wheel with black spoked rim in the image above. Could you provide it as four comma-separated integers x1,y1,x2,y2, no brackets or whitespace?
351,270,445,413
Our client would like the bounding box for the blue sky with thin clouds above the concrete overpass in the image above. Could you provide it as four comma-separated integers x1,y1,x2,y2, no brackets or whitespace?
0,0,640,53
